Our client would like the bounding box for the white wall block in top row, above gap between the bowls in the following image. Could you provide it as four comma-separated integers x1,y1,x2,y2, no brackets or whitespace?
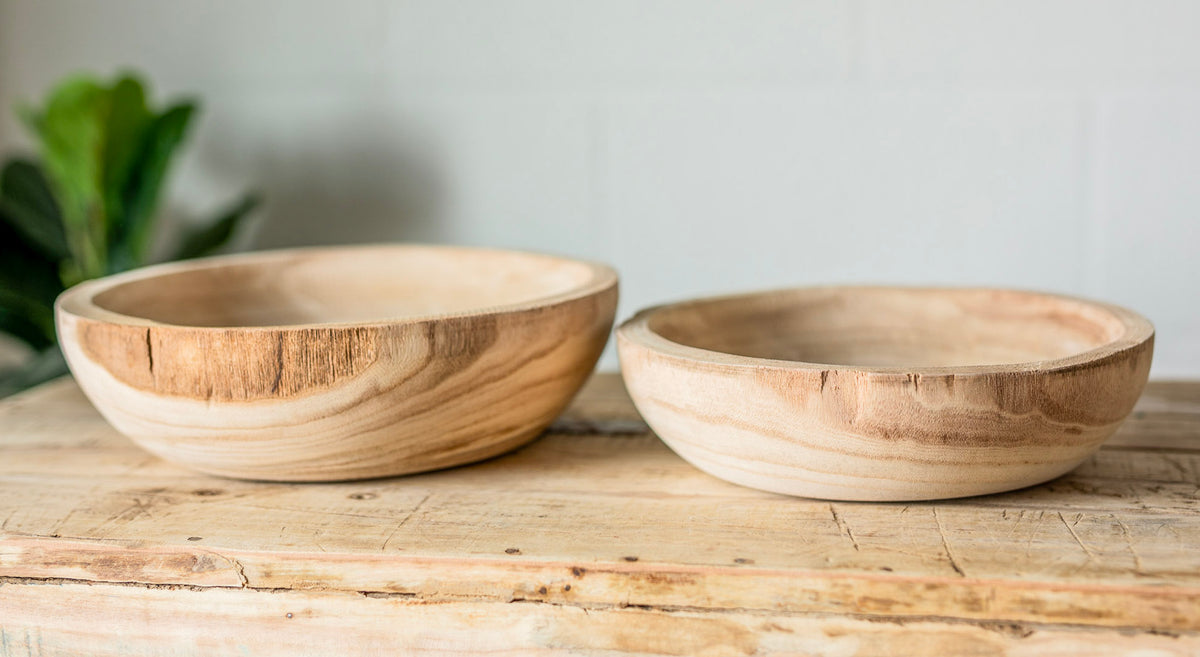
384,0,851,85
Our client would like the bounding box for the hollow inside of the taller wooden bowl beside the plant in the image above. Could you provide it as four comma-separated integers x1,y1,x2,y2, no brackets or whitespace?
92,247,596,327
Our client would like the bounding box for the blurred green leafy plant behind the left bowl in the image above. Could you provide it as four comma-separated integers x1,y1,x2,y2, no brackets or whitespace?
0,74,258,396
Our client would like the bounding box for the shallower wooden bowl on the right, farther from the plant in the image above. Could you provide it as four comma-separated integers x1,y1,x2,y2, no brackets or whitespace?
617,288,1154,501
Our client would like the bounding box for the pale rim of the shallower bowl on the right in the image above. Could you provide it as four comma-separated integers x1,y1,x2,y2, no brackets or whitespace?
617,284,1154,376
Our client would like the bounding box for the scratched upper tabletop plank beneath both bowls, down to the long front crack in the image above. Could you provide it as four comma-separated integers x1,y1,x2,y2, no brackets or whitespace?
0,376,1200,632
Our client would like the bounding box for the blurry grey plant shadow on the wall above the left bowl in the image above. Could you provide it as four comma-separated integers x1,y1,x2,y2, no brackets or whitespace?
170,100,445,249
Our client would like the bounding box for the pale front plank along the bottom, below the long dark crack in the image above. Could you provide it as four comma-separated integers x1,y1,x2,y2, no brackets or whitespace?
0,583,1200,657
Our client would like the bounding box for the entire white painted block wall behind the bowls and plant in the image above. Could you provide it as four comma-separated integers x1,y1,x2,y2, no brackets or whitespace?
0,0,1200,376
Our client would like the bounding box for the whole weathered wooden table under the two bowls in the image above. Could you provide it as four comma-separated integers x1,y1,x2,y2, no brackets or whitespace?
0,375,1200,656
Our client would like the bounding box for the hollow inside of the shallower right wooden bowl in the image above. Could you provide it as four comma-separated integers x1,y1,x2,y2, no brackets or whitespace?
648,288,1126,367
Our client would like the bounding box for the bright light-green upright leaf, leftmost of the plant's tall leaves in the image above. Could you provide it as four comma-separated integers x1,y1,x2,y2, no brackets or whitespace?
36,76,112,277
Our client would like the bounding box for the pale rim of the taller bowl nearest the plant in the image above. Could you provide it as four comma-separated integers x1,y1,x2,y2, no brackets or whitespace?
54,242,618,332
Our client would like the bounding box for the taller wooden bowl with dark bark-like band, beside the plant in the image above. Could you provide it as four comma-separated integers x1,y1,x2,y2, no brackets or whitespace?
58,246,617,481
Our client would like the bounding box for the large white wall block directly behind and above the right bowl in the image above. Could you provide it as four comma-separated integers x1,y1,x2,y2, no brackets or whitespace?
606,90,1085,311
